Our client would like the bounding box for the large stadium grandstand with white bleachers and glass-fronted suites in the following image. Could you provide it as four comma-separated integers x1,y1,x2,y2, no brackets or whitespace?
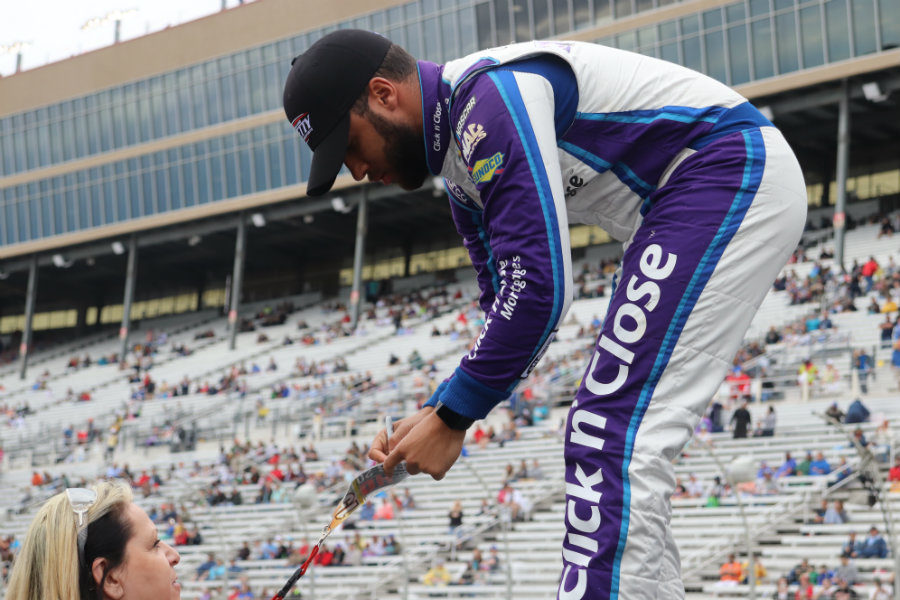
0,0,900,600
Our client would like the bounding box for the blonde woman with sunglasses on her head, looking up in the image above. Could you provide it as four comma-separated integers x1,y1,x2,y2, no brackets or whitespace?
6,482,181,600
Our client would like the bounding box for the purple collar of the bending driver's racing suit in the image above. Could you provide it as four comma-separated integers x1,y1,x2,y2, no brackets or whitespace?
417,60,450,176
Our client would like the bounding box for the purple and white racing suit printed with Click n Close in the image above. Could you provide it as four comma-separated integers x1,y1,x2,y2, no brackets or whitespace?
419,42,807,600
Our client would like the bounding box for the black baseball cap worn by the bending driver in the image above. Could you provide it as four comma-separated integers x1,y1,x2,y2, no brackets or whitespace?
284,29,391,196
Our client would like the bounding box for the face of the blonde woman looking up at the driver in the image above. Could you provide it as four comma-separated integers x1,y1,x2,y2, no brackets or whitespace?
106,503,181,600
